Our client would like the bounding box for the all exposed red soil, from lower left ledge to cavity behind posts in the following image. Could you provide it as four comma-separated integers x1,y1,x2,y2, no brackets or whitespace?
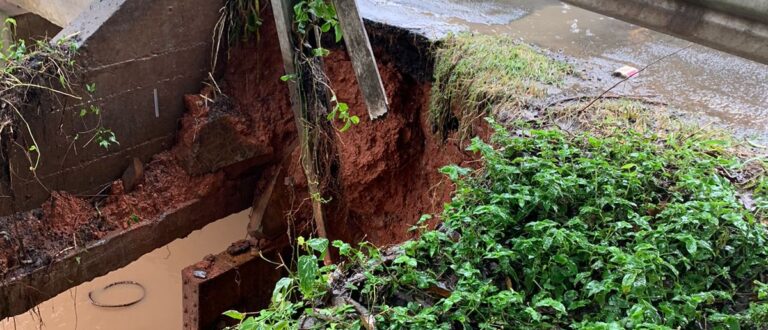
0,10,480,278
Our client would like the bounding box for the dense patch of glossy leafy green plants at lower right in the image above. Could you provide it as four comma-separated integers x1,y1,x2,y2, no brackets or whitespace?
231,115,768,329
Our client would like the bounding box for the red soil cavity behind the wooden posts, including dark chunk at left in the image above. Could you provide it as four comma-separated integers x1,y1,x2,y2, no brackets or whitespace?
195,9,480,245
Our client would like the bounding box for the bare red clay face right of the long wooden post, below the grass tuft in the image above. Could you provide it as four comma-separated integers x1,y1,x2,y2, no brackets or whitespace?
326,52,472,245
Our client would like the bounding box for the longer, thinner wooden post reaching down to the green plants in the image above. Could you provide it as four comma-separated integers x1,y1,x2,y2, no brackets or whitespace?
271,0,333,265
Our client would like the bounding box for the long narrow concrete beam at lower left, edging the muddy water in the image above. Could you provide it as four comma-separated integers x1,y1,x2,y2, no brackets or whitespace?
0,173,256,319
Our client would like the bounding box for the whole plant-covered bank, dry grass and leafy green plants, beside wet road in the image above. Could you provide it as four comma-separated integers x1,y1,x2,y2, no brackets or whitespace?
226,36,768,329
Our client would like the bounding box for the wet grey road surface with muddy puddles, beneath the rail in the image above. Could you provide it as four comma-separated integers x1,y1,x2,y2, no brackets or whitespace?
361,0,768,141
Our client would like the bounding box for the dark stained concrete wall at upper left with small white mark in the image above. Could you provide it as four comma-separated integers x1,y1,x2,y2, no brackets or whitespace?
0,0,223,215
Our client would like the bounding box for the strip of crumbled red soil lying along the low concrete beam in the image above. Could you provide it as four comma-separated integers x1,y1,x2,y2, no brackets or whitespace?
0,152,224,275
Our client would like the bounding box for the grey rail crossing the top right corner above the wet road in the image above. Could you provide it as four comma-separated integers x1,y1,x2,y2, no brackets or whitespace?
565,0,768,64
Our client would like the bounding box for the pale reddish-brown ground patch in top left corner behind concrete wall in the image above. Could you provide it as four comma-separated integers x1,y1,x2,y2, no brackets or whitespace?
0,0,93,26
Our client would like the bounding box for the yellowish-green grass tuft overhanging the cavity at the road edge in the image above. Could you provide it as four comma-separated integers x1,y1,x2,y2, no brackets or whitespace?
430,34,572,137
